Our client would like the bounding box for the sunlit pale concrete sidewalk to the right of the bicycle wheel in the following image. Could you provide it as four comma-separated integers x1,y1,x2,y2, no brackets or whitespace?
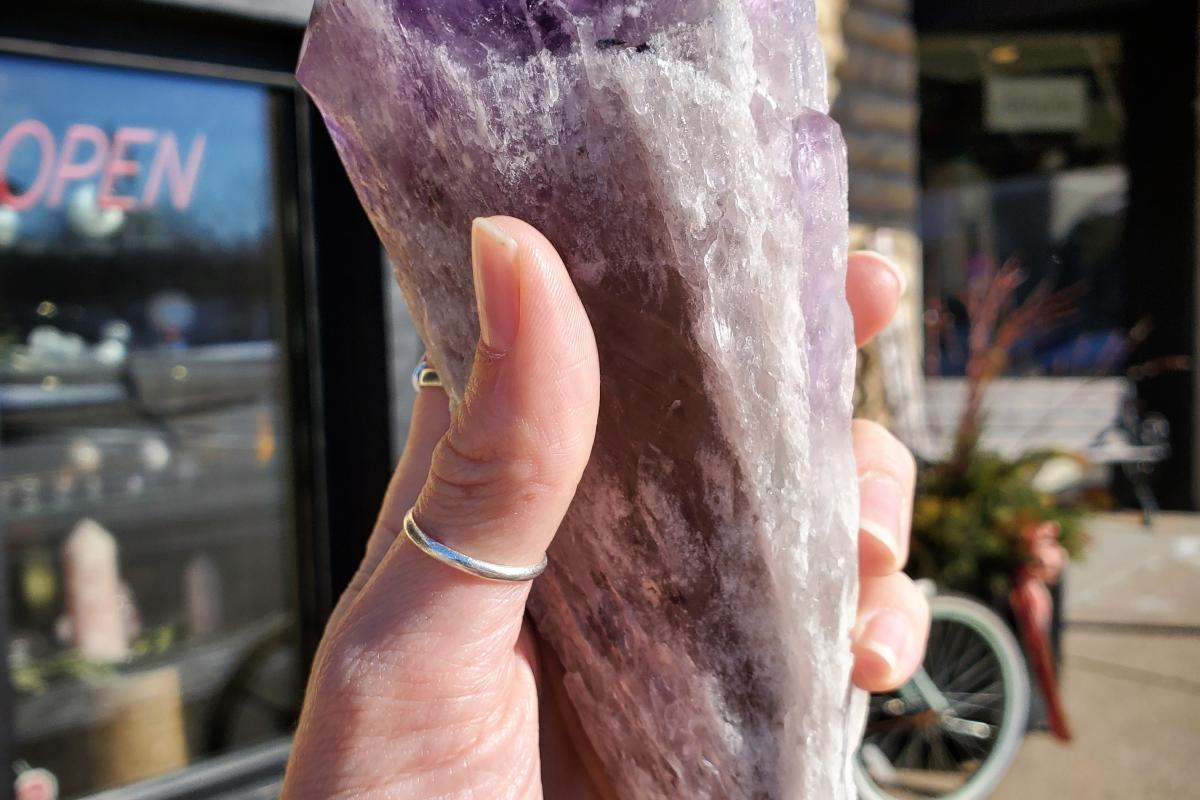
995,513,1200,800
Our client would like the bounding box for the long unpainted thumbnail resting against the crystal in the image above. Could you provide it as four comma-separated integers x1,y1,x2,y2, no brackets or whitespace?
470,217,521,353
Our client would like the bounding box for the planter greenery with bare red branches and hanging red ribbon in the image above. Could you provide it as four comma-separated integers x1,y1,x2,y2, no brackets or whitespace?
908,264,1086,738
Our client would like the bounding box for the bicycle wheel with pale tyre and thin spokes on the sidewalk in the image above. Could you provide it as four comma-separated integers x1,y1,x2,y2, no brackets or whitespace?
854,595,1030,800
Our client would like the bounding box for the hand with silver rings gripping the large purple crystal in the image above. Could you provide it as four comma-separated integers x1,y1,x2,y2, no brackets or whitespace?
283,217,929,800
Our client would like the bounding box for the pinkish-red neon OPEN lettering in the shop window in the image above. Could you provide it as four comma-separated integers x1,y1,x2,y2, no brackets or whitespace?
0,119,206,211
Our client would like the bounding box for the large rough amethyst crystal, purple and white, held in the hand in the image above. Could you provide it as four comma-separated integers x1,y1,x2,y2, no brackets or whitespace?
299,0,859,800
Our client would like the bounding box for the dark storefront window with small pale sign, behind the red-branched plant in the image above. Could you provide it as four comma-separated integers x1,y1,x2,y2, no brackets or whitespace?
920,32,1130,375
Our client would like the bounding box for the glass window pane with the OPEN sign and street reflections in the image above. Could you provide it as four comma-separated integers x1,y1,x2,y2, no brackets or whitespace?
0,55,299,796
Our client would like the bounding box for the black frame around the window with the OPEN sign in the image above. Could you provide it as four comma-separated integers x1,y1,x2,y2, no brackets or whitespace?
0,0,392,800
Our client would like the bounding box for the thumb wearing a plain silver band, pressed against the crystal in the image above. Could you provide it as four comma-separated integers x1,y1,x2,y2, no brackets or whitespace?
336,217,600,657
